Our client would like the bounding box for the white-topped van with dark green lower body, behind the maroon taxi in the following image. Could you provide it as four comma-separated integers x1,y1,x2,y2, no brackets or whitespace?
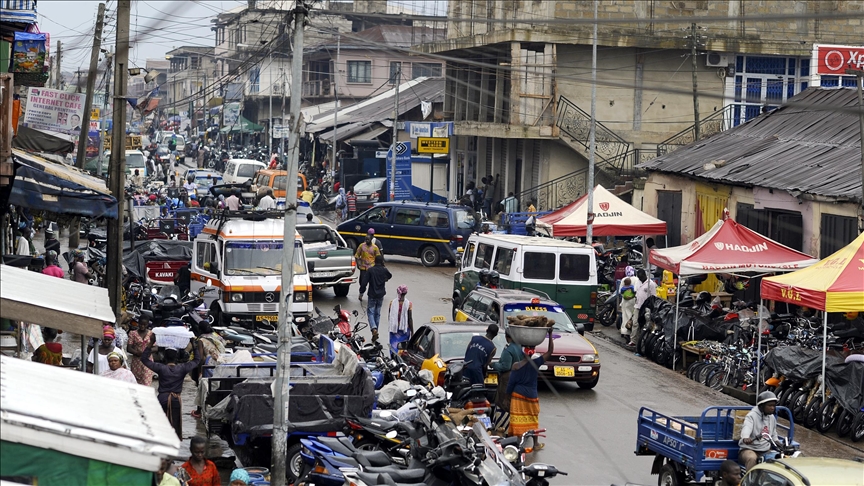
452,233,597,331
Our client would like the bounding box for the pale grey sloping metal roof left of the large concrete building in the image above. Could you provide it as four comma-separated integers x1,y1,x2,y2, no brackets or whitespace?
306,78,444,138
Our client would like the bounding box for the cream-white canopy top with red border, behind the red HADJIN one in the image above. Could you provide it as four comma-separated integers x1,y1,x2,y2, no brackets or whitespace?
537,185,666,237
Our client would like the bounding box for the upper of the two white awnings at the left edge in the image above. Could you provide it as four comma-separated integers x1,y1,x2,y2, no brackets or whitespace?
0,265,114,337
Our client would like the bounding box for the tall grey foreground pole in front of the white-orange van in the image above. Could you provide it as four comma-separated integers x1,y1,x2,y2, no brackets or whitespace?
270,2,306,486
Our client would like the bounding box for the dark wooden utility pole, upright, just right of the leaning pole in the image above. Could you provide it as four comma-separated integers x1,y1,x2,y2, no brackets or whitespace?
106,0,132,319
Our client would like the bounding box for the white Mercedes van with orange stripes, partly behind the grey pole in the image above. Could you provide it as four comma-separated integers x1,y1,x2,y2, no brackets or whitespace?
191,211,313,329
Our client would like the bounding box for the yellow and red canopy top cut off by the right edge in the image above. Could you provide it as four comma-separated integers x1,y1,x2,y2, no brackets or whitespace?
762,233,864,312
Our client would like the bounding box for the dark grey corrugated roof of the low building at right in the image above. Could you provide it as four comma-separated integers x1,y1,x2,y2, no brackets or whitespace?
639,88,861,200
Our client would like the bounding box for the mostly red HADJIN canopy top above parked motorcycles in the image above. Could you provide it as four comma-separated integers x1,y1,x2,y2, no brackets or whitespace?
648,217,818,275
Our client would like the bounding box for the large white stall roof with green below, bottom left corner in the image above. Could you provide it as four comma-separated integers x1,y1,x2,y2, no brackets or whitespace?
0,354,180,471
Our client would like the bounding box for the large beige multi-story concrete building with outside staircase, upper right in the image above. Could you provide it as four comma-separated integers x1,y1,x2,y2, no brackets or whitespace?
422,0,864,209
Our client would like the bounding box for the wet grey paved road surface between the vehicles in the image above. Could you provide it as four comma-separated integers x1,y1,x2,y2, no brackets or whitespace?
326,252,864,485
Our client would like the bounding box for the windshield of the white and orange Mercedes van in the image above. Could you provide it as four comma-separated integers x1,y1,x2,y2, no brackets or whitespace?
225,241,306,276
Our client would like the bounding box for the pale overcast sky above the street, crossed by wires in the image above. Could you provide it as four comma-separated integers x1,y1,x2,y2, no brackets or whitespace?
37,0,447,72
